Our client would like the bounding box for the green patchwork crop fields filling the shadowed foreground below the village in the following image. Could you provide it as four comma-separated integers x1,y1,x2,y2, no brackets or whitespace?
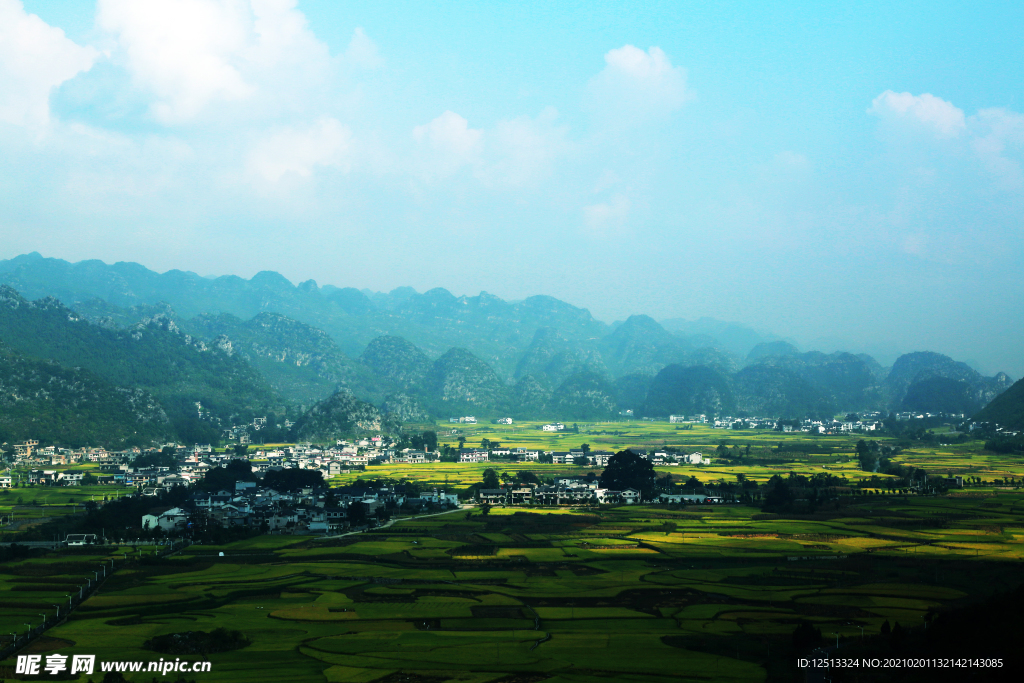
6,489,1024,683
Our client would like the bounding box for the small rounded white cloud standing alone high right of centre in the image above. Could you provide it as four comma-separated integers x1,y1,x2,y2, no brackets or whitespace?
587,45,688,124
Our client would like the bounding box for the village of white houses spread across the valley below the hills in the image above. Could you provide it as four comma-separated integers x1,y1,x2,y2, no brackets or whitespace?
0,428,745,544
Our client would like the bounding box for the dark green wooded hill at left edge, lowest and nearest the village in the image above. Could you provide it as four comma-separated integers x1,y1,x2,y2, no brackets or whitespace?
0,344,175,447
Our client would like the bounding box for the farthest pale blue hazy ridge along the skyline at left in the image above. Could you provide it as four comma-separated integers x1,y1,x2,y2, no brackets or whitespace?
0,254,609,378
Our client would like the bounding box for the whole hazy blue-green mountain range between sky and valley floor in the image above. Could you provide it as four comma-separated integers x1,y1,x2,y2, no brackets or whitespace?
0,254,1012,440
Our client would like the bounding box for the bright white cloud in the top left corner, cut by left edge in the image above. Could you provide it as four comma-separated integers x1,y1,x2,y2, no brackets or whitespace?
0,0,98,128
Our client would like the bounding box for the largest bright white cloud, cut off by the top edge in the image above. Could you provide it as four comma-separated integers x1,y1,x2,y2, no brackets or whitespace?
97,0,330,124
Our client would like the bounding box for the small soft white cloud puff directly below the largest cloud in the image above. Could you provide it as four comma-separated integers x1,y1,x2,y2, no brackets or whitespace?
249,118,352,182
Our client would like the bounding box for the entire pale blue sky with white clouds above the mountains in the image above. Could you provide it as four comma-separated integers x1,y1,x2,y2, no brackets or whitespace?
0,0,1024,379
